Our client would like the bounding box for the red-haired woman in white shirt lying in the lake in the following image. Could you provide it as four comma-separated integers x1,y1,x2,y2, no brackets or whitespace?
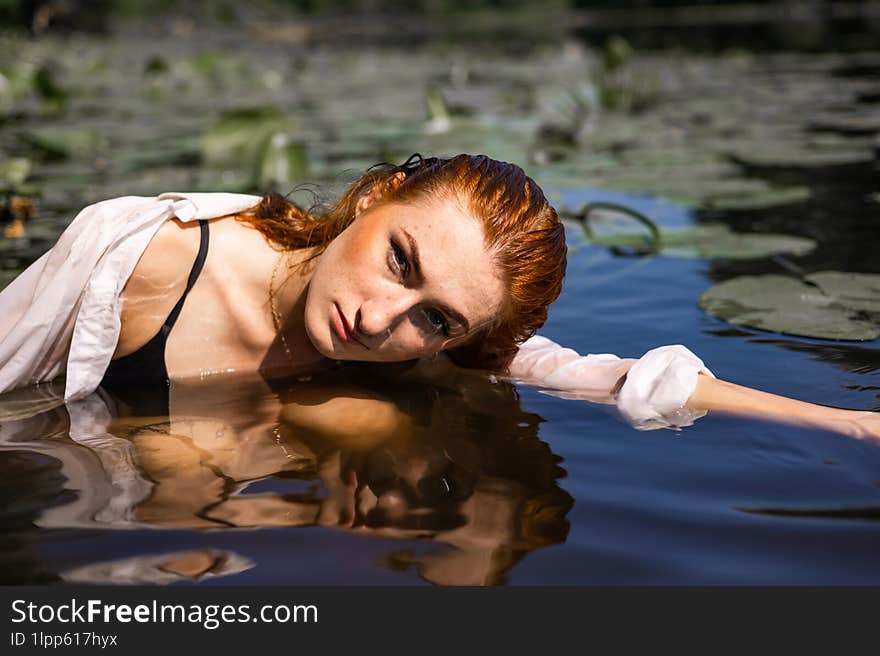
0,155,880,437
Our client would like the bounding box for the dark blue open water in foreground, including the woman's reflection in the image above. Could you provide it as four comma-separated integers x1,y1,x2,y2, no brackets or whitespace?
0,190,880,585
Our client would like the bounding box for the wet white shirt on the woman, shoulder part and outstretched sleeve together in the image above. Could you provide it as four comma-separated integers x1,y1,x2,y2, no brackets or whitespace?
0,192,712,429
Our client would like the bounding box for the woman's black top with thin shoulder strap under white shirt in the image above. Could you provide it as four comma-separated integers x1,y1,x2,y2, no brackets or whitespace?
101,220,208,415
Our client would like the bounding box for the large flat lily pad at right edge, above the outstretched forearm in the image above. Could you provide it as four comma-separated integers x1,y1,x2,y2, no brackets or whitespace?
698,271,880,341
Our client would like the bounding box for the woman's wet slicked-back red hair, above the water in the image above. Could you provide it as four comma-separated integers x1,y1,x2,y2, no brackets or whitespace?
240,155,566,370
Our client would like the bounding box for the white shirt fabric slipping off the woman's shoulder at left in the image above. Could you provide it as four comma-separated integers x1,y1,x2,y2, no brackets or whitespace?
0,192,260,400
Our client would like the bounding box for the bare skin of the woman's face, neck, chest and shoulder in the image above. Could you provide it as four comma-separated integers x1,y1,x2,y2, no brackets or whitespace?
114,191,506,378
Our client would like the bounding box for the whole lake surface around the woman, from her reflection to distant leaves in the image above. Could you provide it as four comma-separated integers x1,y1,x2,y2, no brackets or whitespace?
0,20,880,585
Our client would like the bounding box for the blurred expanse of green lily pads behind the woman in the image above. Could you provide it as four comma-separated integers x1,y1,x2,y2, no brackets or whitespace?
0,25,877,308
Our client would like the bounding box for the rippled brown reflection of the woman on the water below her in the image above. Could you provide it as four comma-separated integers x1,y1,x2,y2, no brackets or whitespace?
2,369,572,585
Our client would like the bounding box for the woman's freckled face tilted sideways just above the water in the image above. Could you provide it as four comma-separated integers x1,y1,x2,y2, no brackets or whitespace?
305,199,505,362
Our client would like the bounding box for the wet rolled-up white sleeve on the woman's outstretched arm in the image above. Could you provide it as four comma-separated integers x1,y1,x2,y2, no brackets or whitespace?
510,335,714,430
